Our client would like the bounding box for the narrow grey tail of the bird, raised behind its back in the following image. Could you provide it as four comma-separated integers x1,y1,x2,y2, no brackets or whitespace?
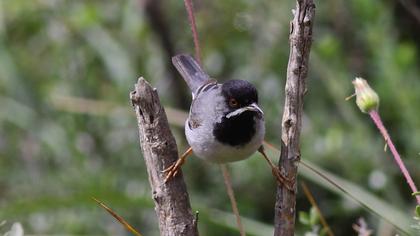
172,54,210,97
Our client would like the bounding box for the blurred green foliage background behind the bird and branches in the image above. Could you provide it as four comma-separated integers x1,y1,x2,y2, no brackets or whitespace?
0,0,420,235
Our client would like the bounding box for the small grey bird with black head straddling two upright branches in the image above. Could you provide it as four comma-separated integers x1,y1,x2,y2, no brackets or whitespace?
164,54,289,190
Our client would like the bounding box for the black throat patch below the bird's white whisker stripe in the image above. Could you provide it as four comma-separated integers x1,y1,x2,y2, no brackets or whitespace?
213,111,256,146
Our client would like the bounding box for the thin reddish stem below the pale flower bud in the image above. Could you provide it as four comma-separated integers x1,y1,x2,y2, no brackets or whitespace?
369,110,420,205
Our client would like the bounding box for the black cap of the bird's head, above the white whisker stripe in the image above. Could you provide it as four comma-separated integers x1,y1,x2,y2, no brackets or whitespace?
222,80,258,110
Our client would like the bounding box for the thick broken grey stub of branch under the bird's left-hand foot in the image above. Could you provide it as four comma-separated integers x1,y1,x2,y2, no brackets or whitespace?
130,78,198,236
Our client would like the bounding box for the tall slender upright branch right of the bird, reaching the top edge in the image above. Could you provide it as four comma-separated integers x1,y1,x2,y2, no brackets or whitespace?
274,0,315,236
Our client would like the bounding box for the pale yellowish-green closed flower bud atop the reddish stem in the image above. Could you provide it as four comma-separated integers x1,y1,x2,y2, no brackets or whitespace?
353,77,379,113
